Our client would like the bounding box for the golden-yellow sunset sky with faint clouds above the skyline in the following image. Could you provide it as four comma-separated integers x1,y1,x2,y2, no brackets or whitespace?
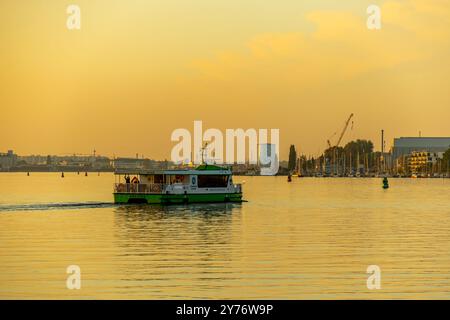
0,0,450,159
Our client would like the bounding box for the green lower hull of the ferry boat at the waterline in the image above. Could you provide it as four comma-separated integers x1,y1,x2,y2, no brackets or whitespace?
114,192,242,204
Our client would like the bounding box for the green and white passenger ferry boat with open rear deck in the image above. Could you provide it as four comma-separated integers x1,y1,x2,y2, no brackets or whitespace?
114,164,243,204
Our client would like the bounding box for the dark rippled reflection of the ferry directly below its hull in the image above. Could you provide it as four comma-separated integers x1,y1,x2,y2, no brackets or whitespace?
114,203,237,255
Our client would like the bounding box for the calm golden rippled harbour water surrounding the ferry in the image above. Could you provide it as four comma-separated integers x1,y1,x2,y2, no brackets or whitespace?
0,173,450,299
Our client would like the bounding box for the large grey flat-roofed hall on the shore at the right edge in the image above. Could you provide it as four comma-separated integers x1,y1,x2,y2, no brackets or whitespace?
392,137,450,163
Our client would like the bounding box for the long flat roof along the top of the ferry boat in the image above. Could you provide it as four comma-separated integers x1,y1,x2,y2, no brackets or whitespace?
114,164,232,175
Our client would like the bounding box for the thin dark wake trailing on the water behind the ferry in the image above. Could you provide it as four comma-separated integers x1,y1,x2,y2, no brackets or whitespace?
0,202,115,212
